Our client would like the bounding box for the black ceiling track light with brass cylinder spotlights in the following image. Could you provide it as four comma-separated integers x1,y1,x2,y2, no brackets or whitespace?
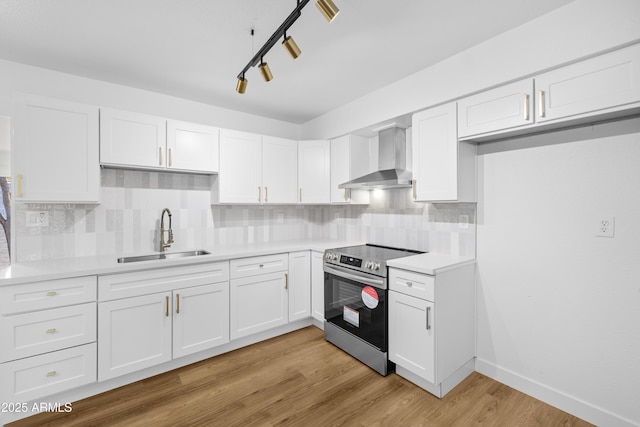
236,0,340,93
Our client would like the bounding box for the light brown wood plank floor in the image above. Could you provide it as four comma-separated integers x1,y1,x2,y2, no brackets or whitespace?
9,326,591,427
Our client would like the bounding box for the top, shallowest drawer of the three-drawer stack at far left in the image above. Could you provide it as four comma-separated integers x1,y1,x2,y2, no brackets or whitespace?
0,276,96,314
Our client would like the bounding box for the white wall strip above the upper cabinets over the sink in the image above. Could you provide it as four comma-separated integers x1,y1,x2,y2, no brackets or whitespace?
0,60,300,139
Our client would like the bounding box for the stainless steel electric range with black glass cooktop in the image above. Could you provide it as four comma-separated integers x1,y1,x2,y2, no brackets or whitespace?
324,244,423,375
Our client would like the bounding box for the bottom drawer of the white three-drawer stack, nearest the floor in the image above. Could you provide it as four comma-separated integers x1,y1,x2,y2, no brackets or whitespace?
0,343,96,402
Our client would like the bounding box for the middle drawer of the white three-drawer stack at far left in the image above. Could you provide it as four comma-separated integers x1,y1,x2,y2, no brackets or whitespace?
0,302,97,362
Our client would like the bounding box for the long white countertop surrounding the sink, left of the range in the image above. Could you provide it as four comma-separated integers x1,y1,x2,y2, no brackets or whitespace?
0,240,362,286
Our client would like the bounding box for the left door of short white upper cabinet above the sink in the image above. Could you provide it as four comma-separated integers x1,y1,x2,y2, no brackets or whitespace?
100,108,167,169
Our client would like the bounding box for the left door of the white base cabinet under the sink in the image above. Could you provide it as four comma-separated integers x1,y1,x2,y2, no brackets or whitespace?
98,292,171,381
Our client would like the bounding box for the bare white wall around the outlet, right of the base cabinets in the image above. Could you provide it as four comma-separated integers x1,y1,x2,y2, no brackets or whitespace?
477,118,640,426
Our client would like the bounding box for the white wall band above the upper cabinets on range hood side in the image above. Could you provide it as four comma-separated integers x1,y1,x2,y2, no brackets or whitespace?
302,0,640,139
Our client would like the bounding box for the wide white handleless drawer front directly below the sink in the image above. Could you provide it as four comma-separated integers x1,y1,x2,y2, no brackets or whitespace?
98,262,229,301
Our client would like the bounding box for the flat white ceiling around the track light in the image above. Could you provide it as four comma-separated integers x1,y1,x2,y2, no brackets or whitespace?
0,0,572,124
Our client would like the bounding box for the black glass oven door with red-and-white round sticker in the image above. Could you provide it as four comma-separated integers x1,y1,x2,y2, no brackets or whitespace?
324,264,388,352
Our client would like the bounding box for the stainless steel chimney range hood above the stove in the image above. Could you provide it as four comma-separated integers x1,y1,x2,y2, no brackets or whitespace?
338,127,411,190
